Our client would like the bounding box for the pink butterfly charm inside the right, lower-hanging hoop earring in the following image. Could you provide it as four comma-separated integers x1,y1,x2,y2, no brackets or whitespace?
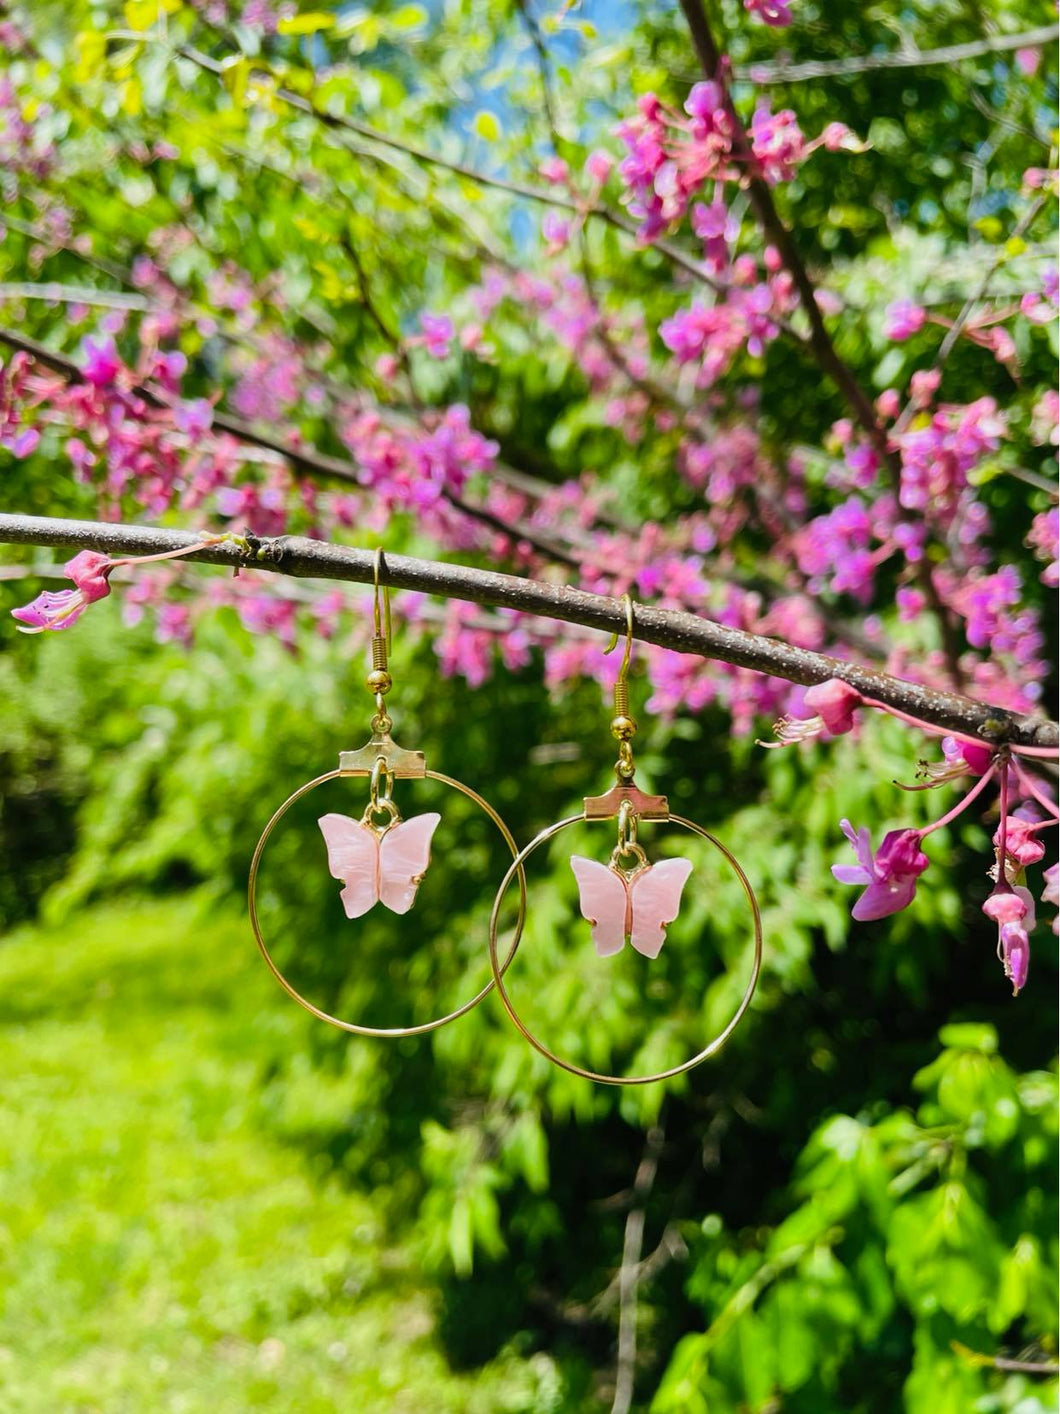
571,854,693,957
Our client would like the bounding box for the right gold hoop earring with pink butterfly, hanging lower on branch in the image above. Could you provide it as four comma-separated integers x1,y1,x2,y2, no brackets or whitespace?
489,594,762,1085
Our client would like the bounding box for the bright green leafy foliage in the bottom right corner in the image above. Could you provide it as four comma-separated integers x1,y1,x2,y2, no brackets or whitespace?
661,1024,1057,1414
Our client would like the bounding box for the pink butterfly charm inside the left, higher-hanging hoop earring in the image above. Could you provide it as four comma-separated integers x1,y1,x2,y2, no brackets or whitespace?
317,814,441,918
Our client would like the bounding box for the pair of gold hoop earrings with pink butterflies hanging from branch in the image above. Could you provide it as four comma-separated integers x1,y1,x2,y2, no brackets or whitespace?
247,550,762,1085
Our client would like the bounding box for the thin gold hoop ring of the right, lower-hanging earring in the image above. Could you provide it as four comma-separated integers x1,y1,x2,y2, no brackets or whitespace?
489,802,762,1085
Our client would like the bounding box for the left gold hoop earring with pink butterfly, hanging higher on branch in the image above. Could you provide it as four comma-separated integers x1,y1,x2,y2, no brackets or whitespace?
247,549,526,1036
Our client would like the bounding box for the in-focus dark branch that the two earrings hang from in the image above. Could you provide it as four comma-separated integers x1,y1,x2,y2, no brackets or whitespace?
0,515,1060,749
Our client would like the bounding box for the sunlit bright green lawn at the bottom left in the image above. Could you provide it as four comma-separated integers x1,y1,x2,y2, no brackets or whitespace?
0,898,560,1414
